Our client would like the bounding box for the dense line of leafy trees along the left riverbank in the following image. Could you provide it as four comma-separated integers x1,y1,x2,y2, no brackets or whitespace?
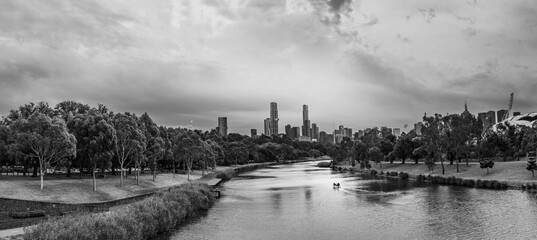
0,101,330,190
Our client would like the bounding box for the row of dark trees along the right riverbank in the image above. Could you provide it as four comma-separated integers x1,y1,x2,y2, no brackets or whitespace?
328,112,537,174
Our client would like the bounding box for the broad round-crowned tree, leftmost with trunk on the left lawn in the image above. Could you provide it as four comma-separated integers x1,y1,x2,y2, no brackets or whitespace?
13,112,76,189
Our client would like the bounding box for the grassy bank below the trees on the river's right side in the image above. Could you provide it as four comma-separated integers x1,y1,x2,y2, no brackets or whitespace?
332,160,537,189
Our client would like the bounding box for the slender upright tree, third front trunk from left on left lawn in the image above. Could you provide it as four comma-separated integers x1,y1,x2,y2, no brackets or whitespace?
112,113,145,187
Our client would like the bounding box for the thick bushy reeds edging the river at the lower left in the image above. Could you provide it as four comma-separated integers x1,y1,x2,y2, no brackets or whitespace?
23,183,214,240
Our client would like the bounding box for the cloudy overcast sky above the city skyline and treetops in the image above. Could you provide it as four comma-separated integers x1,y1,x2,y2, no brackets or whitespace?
0,0,537,134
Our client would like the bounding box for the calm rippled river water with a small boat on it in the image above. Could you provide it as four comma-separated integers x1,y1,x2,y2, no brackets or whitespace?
170,162,537,240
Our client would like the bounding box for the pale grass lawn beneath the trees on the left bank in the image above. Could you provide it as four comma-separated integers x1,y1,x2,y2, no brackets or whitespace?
0,167,226,203
